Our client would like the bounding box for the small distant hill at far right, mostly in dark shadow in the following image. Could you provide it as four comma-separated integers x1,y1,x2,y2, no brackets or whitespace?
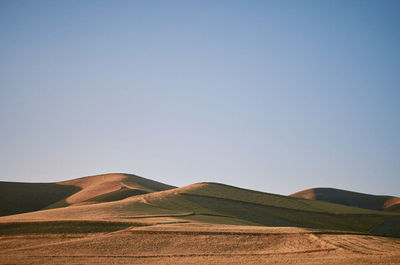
289,188,400,211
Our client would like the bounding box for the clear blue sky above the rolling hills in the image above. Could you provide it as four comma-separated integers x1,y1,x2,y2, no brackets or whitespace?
0,0,400,196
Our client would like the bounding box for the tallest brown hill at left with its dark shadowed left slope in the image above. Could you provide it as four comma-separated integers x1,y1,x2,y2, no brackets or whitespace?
0,173,175,216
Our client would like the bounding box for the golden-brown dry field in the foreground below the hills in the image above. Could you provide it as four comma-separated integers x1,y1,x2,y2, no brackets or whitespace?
0,223,400,265
